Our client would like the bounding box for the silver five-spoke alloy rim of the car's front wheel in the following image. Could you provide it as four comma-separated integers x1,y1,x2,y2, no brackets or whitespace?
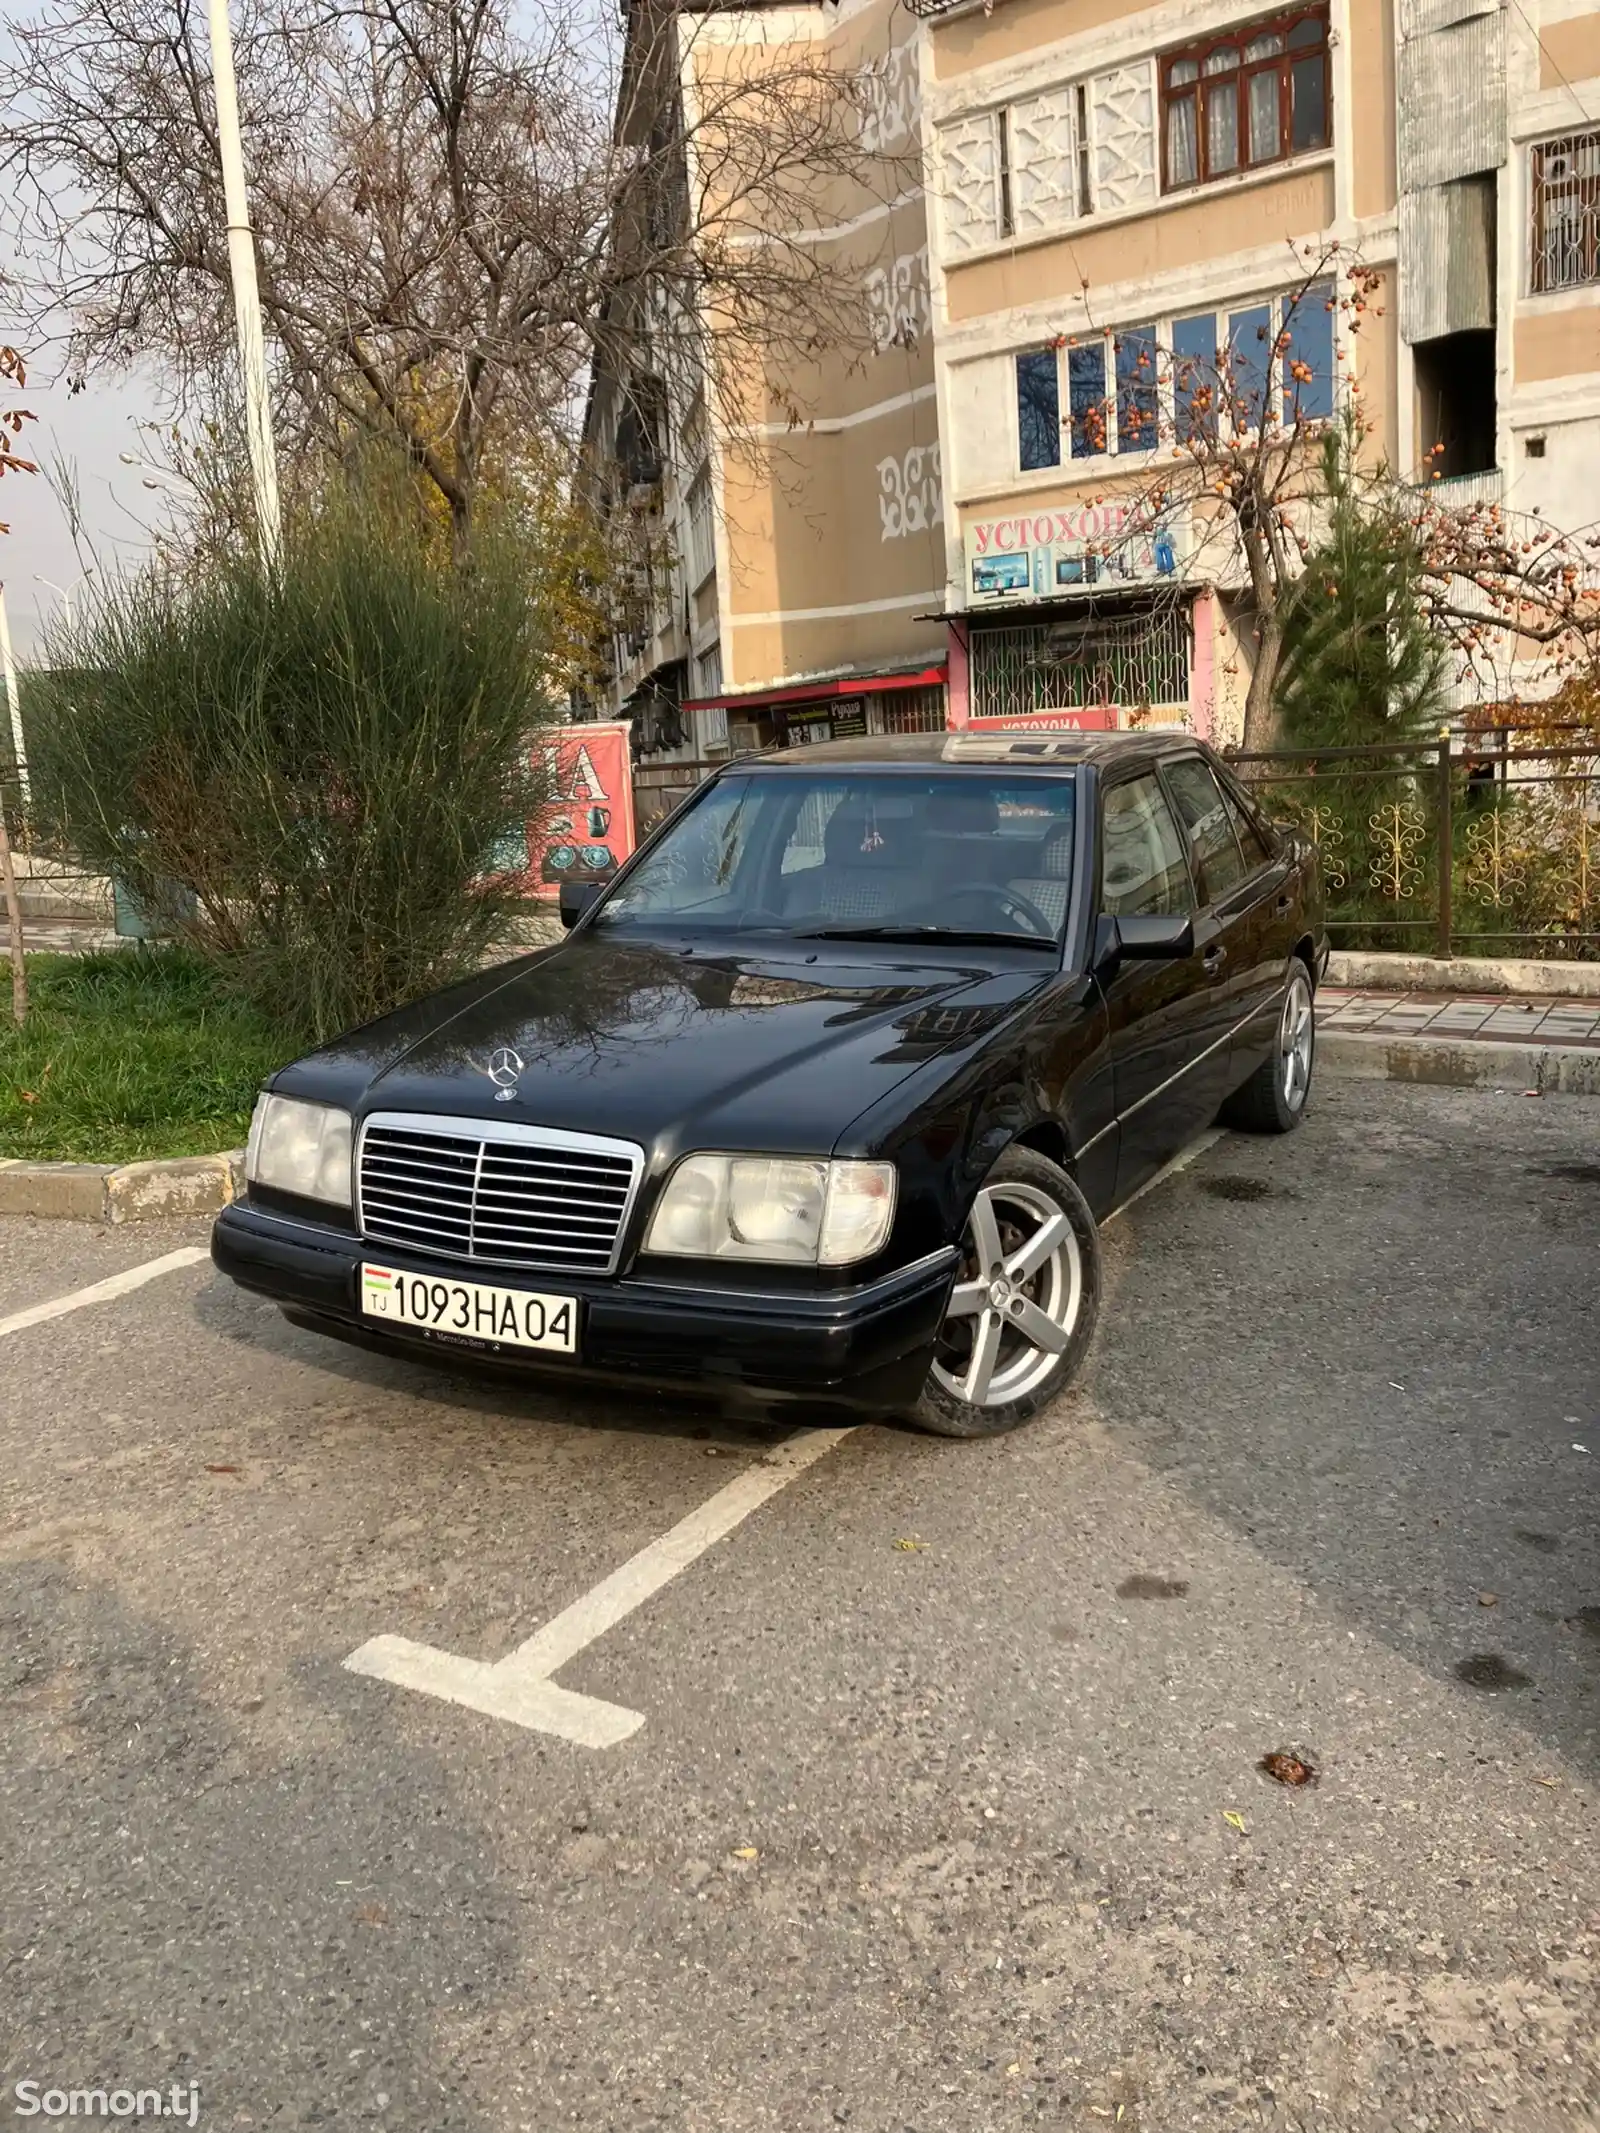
932,1182,1084,1408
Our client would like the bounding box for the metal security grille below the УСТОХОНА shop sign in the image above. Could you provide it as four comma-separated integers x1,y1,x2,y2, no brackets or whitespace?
969,608,1188,719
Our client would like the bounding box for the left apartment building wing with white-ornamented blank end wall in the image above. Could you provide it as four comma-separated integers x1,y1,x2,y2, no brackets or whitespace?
585,0,960,761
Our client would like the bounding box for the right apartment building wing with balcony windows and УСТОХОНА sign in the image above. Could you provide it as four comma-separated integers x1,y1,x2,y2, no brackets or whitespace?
909,0,1600,742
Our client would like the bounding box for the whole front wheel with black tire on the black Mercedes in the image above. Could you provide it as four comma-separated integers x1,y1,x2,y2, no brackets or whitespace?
915,1148,1101,1438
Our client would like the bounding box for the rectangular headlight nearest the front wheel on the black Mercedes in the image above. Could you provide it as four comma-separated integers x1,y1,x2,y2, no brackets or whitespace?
644,1156,894,1267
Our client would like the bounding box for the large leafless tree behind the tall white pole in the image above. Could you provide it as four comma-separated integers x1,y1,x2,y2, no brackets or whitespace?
0,0,896,552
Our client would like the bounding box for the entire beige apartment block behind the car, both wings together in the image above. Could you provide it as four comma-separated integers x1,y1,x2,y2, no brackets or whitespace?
589,0,1600,759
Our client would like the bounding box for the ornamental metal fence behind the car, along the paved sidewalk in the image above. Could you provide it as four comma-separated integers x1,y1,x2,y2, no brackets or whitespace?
1229,736,1600,962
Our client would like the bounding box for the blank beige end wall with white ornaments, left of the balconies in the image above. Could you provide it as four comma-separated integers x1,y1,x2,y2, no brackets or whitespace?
689,0,943,708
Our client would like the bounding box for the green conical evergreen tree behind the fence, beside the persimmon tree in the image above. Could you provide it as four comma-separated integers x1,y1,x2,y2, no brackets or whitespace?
1278,422,1449,749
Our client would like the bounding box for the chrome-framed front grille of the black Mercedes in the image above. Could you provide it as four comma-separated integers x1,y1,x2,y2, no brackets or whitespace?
356,1111,644,1273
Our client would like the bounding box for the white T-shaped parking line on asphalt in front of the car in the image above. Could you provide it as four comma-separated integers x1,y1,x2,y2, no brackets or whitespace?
343,1425,860,1747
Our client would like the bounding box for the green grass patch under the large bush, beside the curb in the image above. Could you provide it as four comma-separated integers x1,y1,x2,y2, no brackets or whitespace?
0,949,294,1162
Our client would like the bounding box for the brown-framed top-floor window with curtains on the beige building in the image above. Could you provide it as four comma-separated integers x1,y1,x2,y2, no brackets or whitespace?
1161,6,1331,192
